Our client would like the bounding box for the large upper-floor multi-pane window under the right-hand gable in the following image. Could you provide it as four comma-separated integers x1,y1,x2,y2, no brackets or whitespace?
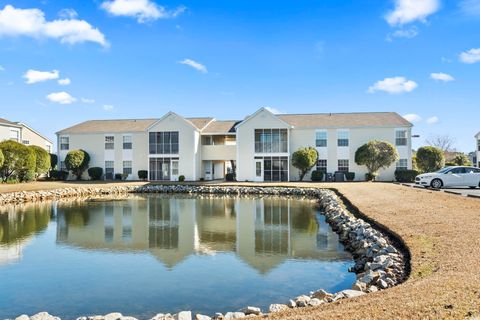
255,129,288,153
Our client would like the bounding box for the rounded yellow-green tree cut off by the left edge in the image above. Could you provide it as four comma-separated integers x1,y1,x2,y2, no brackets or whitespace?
0,140,35,182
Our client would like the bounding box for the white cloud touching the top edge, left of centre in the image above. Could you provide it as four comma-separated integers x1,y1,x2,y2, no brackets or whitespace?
101,0,186,23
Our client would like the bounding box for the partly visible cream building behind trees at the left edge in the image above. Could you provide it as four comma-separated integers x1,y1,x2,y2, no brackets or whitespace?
0,118,53,153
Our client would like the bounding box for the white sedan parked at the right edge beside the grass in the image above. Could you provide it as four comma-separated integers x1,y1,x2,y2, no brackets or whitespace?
415,167,480,189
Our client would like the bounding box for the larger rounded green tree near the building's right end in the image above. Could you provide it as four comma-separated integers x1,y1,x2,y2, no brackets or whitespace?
355,140,399,180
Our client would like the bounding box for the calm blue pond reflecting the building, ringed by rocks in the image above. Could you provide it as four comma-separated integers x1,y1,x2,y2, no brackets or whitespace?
0,195,355,319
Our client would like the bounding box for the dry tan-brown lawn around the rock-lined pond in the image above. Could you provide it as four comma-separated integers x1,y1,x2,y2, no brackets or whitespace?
0,182,480,320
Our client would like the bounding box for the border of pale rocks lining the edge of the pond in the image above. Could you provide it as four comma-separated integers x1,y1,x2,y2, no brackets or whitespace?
0,185,409,320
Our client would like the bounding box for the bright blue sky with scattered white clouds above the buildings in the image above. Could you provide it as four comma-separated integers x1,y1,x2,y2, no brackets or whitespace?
0,0,480,152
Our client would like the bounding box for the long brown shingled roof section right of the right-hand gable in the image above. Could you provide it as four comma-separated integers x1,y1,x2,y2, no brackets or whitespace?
276,112,413,129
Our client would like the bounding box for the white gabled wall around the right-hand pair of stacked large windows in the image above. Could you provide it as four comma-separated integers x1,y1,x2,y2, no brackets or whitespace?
237,110,289,181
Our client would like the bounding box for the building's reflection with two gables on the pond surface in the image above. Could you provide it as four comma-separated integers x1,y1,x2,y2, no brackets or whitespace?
57,197,349,272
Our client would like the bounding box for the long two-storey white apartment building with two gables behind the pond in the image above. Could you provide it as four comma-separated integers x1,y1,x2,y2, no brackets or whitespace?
57,108,412,181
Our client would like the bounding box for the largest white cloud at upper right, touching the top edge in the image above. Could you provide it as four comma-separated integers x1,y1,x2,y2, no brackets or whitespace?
385,0,440,26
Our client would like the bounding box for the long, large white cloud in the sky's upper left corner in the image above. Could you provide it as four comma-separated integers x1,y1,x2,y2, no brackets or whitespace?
0,5,108,46
